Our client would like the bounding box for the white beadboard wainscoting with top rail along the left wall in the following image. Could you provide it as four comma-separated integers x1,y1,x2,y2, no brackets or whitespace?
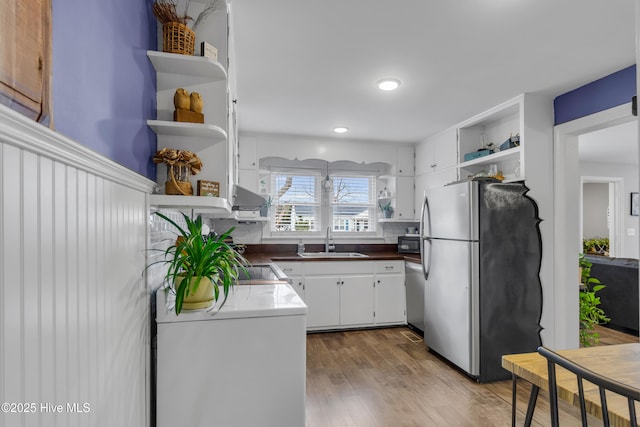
0,105,154,427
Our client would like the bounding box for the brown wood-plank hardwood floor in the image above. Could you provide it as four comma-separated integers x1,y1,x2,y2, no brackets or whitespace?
307,328,638,427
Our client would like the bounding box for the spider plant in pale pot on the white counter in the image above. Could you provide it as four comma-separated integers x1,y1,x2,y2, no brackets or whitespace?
153,212,249,314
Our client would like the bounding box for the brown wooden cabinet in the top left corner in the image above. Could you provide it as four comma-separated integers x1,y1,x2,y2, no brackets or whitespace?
0,0,51,124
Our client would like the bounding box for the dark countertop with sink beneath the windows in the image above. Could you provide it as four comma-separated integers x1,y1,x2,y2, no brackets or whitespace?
244,244,420,264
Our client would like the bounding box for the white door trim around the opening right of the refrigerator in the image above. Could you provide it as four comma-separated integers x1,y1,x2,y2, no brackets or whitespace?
548,103,634,349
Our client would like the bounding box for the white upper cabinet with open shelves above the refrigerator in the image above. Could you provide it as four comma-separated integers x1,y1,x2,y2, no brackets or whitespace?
415,93,553,222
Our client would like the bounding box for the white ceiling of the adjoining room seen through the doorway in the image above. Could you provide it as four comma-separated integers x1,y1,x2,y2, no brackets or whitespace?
578,120,638,165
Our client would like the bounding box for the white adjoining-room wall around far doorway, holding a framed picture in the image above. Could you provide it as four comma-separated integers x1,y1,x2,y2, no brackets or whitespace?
580,162,640,258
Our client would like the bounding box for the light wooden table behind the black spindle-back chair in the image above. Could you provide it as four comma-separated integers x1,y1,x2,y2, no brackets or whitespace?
502,343,640,427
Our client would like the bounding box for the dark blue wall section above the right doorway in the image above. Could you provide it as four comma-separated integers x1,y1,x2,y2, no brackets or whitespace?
553,65,636,125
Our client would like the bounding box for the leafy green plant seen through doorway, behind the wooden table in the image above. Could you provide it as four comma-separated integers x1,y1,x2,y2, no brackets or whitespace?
578,254,611,347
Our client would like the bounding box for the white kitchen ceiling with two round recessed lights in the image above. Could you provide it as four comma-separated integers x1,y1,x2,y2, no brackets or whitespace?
231,0,635,142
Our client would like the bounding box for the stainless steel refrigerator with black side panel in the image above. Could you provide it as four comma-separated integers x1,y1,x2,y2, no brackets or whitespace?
420,180,542,382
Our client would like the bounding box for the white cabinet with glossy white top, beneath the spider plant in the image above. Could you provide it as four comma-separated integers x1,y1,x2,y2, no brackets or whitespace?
156,284,307,427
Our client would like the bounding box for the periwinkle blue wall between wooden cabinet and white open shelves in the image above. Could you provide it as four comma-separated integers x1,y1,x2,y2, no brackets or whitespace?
52,0,157,181
